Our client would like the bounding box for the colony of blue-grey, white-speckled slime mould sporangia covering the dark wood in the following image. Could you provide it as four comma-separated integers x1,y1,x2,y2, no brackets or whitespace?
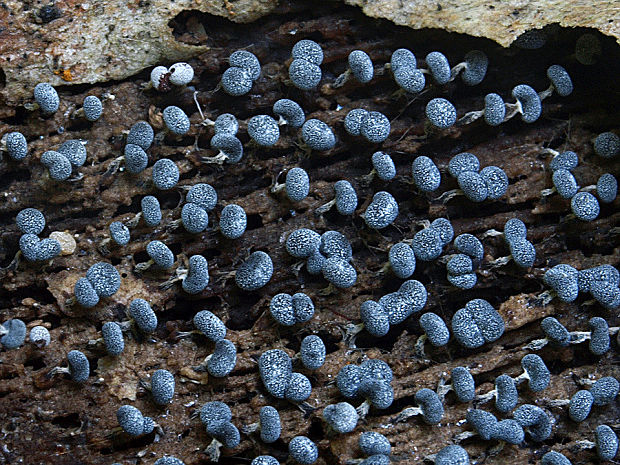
0,30,620,465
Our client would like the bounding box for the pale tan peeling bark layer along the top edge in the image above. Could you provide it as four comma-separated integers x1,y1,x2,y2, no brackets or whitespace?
0,0,620,104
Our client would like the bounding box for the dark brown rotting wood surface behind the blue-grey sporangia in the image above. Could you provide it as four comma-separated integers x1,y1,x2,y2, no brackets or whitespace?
0,4,620,465
